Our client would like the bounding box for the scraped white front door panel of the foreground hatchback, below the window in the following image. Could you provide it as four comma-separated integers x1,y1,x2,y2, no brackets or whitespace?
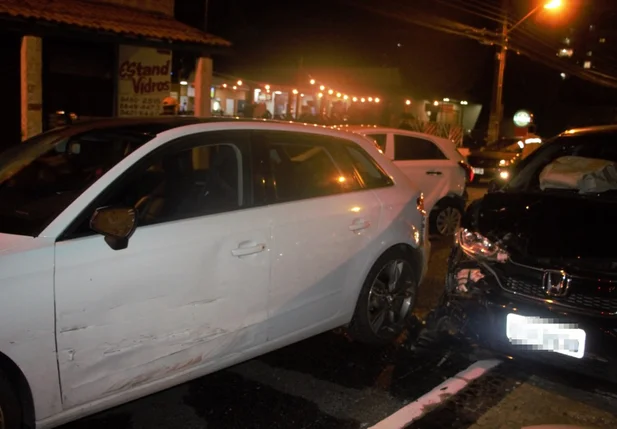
56,208,271,408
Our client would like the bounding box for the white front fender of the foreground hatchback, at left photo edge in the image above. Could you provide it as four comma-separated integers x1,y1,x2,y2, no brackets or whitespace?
0,234,61,418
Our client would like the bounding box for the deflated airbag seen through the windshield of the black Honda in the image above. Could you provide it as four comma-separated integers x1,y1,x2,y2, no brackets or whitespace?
540,156,617,194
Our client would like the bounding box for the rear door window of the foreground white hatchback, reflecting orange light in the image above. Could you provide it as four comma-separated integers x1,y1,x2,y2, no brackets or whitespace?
259,132,356,202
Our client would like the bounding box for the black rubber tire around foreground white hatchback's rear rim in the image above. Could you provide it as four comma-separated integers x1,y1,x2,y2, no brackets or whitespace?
348,247,418,346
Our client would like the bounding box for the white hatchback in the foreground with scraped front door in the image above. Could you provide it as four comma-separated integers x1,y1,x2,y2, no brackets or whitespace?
0,117,430,429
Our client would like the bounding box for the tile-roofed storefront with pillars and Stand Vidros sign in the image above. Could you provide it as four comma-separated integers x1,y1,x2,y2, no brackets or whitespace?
0,0,231,149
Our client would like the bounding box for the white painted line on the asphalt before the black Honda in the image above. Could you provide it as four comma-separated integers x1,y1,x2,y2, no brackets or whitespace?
370,359,501,429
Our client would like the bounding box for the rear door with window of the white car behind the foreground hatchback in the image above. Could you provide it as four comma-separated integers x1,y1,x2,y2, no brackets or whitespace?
389,134,460,210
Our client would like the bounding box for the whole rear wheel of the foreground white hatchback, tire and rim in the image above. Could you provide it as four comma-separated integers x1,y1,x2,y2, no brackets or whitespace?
349,249,418,346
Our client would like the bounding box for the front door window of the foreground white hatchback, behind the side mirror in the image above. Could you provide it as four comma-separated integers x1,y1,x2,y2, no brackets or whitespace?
67,132,247,236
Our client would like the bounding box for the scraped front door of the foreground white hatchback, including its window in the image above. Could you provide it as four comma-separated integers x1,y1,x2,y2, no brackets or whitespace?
48,131,271,409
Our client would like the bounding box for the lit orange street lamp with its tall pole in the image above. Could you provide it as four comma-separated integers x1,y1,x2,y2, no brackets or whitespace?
488,0,563,141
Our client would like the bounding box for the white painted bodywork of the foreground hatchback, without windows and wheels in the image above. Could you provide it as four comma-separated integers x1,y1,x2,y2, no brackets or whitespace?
0,118,429,428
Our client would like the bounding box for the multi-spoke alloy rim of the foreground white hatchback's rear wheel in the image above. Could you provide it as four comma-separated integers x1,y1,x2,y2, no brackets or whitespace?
368,259,416,336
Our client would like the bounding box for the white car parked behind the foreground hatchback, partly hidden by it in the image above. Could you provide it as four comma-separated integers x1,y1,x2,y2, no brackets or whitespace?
341,126,473,236
